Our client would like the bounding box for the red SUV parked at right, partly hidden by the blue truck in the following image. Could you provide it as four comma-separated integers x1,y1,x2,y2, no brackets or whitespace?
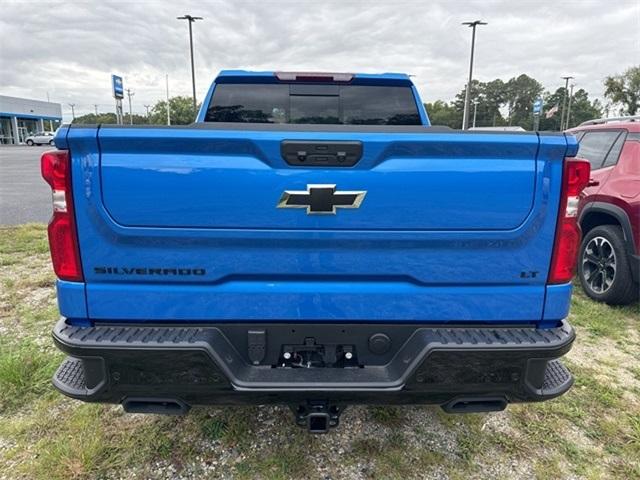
568,116,640,304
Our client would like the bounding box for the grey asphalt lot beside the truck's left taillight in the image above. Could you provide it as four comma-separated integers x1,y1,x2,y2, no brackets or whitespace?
0,145,52,225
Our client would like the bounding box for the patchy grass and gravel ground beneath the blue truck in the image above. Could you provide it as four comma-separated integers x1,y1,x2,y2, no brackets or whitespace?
0,225,640,480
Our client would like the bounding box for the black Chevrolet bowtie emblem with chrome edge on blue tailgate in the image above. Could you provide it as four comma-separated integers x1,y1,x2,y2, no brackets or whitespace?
278,185,367,215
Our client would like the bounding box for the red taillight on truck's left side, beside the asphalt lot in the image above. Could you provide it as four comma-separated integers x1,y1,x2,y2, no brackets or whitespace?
40,150,82,282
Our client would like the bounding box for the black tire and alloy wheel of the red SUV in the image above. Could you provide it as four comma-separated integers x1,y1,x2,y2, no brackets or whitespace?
578,225,638,305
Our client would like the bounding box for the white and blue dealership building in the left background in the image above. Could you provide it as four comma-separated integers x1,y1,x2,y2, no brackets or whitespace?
0,95,62,144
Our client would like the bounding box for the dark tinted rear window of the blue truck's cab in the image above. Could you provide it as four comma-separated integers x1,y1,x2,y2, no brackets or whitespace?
205,83,422,125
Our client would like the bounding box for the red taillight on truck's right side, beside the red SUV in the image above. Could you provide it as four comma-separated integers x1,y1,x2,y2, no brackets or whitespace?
548,158,591,284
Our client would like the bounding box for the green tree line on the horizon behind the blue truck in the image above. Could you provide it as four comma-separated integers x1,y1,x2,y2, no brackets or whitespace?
73,65,640,130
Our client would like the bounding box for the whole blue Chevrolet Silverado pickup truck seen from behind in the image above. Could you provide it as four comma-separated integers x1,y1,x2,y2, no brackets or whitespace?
42,71,589,432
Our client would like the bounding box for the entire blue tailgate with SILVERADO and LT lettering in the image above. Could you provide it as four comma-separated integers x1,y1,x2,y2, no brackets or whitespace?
62,124,575,322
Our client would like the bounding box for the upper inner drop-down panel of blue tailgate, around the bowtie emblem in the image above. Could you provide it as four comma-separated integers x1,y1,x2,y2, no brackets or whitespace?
99,128,538,230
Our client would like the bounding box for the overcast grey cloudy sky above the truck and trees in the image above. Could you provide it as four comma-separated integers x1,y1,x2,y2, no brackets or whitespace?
0,0,640,120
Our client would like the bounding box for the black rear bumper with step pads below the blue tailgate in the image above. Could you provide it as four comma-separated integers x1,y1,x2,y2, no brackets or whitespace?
53,319,575,413
